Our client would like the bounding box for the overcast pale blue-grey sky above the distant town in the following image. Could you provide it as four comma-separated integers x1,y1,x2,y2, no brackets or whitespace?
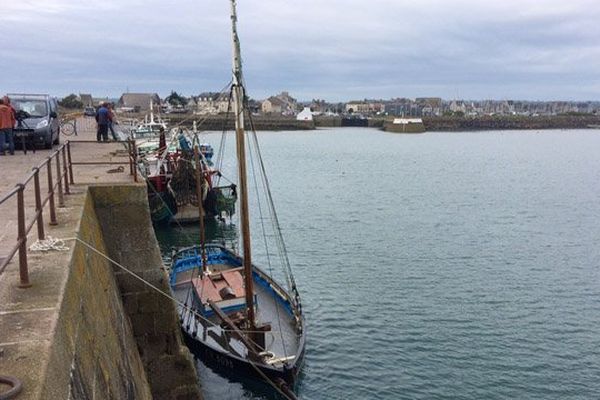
0,0,600,102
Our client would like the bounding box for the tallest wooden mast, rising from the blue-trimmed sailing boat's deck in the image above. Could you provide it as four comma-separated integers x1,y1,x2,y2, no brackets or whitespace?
231,0,256,330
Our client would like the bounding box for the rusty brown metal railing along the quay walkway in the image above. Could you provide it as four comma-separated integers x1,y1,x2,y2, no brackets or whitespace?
0,140,137,288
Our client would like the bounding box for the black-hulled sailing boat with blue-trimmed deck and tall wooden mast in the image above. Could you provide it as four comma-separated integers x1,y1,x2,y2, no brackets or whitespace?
170,0,305,398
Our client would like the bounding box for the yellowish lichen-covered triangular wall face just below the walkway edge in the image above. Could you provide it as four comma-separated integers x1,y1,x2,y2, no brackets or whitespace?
41,188,152,399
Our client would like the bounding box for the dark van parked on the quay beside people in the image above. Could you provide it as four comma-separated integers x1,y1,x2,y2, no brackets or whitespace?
8,93,60,149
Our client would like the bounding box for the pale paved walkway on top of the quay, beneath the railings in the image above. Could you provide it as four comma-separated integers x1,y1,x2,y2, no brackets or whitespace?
0,118,139,399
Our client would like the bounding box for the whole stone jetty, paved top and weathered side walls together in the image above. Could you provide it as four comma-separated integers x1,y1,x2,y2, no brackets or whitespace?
0,117,201,400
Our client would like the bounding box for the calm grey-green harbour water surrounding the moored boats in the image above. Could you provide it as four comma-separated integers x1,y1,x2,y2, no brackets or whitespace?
158,128,600,400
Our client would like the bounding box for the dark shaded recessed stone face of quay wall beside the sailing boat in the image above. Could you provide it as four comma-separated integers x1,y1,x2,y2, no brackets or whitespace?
90,185,199,399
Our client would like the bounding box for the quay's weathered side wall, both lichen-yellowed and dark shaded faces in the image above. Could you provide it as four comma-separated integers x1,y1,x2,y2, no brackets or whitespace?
42,185,201,400
